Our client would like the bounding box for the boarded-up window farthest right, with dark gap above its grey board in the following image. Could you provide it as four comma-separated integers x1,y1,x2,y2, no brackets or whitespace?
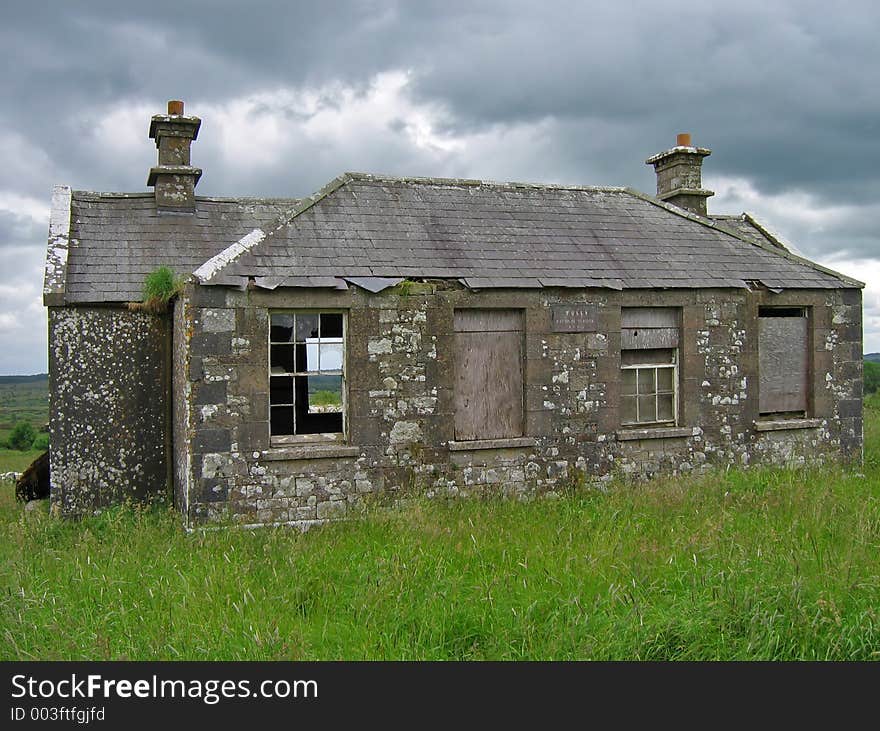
758,307,810,416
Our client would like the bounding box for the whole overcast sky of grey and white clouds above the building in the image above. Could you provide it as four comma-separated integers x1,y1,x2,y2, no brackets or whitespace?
0,0,880,374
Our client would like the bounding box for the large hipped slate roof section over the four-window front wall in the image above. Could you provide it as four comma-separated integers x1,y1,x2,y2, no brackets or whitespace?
197,173,861,289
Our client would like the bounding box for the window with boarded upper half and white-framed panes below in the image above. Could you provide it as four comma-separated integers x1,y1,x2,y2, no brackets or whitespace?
620,307,679,426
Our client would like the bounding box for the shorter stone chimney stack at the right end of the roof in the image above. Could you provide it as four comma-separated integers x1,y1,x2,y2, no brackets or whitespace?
645,132,715,216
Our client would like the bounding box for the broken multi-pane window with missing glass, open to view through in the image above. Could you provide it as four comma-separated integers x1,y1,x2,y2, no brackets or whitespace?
269,312,345,439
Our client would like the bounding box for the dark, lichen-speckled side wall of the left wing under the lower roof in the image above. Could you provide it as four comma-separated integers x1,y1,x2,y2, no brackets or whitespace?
49,307,169,516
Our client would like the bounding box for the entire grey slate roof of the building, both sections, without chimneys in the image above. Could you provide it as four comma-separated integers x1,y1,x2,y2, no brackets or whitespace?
53,173,863,303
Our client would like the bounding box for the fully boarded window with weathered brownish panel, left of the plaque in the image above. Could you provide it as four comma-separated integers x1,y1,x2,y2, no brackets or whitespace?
455,310,523,441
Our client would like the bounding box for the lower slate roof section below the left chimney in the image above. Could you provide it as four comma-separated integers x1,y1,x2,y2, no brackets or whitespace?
65,191,298,302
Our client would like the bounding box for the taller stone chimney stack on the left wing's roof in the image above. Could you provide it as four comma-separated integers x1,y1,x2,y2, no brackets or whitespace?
147,100,202,213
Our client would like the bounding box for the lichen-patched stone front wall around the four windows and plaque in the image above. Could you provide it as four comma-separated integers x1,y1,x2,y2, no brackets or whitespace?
177,283,862,525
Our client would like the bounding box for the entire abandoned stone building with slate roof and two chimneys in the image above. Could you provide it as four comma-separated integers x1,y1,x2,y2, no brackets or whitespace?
45,102,863,526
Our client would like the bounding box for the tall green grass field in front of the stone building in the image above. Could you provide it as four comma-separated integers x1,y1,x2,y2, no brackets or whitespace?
0,396,880,660
